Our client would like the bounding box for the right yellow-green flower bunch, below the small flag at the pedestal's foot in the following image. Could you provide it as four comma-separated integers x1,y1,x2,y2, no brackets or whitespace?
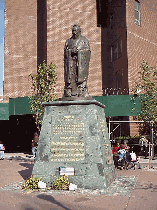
52,175,70,190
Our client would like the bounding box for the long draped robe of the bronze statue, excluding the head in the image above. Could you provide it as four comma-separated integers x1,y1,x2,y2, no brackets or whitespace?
64,35,91,95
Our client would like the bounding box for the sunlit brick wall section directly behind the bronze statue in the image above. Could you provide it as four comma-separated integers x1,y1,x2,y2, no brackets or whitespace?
47,0,102,97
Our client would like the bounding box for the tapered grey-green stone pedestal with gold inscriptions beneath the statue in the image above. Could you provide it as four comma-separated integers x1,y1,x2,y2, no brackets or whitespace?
32,100,115,189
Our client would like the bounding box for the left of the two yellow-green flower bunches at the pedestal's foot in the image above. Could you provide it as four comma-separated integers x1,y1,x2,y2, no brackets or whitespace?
22,175,42,190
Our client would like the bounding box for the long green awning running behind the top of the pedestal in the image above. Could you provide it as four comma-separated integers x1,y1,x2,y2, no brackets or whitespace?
9,95,141,117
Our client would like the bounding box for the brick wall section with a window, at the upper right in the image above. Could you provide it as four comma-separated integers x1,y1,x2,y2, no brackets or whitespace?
126,0,157,92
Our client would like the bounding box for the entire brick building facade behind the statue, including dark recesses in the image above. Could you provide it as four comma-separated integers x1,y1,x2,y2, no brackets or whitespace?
3,0,157,138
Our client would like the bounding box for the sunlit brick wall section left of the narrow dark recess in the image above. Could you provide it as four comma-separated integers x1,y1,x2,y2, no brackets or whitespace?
3,0,37,102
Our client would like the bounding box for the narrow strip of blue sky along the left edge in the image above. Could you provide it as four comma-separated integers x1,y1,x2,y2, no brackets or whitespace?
0,0,4,95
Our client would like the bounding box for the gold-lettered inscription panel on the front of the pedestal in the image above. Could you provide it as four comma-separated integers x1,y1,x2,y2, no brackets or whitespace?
51,116,84,162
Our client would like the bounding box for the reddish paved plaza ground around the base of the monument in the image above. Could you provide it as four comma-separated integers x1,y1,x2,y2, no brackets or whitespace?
0,153,157,210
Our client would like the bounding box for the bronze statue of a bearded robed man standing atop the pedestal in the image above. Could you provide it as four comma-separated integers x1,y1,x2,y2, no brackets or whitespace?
64,24,91,100
